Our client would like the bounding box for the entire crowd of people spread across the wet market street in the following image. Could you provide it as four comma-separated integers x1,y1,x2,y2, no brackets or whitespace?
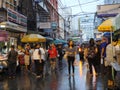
0,37,120,88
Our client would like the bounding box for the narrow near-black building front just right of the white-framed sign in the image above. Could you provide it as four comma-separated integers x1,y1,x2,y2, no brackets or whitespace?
17,0,36,33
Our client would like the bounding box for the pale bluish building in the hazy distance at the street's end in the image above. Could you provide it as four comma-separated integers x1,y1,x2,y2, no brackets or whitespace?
80,14,94,42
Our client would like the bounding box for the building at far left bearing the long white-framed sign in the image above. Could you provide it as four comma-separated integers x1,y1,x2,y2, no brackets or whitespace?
0,0,27,46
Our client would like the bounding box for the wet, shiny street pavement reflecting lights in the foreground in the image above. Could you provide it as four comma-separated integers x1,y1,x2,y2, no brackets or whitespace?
0,54,111,90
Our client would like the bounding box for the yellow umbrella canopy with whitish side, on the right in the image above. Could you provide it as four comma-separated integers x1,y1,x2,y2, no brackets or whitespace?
98,18,115,32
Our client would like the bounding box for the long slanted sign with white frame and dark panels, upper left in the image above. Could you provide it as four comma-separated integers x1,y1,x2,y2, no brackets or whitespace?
7,9,27,27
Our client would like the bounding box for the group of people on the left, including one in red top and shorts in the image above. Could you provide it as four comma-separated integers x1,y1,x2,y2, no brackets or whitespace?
5,43,63,78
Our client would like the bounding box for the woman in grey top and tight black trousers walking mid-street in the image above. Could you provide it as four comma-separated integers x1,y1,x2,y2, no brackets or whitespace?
66,40,76,76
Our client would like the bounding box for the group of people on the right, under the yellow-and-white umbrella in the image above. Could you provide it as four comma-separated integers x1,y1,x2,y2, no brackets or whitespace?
80,37,120,86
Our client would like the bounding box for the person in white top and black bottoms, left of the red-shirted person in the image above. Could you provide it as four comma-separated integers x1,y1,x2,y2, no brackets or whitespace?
32,44,42,78
